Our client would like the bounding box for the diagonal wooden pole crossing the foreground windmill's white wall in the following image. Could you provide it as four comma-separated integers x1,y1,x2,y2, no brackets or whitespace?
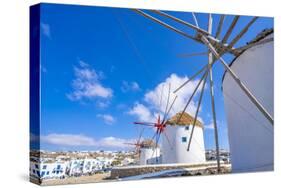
202,36,274,126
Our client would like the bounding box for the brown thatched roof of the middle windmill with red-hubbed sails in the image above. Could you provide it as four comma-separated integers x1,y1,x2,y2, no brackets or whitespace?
167,112,203,128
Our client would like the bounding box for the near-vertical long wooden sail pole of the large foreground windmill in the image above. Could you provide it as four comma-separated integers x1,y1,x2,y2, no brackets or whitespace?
208,14,220,173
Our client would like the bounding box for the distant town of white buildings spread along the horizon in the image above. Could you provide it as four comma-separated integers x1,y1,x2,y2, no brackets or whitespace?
30,150,230,185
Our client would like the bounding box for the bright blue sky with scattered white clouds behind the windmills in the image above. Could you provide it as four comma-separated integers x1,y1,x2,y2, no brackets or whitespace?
31,4,273,150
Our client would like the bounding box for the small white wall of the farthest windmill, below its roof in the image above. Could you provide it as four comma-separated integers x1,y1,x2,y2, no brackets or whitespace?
140,148,160,165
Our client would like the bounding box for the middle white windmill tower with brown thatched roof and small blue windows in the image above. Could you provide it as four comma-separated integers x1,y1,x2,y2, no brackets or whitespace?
161,112,206,164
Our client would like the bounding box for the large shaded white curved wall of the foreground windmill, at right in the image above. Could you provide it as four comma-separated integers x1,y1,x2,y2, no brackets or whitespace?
223,35,274,172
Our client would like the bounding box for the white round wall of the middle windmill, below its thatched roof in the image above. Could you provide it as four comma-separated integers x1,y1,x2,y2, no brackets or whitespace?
162,126,206,164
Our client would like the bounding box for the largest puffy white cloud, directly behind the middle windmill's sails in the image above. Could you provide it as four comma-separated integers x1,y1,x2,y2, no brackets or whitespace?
129,74,203,122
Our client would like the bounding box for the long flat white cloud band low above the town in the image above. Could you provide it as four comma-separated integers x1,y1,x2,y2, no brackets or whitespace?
41,133,135,148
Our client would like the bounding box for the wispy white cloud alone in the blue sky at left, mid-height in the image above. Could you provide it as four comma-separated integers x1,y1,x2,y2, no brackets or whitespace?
67,61,113,101
